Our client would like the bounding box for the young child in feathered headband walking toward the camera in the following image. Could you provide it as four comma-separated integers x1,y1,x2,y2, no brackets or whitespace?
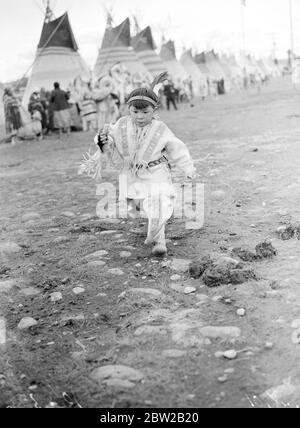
82,74,195,256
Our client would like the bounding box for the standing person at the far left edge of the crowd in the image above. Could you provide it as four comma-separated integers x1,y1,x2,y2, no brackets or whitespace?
3,88,22,144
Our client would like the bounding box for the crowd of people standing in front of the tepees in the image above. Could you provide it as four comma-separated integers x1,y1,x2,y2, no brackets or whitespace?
3,66,274,143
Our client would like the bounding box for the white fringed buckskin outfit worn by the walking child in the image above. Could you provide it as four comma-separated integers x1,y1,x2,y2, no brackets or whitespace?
95,116,195,251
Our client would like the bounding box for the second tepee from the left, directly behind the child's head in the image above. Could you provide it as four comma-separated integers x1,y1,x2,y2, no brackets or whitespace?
94,18,149,79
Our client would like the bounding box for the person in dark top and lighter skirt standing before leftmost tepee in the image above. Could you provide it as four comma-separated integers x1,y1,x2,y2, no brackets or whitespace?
51,82,71,138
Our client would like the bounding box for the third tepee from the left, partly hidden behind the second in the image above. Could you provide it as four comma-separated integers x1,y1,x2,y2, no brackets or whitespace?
132,27,167,77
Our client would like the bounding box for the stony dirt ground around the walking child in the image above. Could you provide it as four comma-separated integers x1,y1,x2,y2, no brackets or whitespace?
0,78,300,408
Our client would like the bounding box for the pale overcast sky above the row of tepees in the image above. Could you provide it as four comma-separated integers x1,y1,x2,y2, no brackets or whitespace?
0,0,300,82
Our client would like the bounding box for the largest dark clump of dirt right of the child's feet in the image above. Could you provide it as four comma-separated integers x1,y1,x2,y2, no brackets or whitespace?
189,256,257,287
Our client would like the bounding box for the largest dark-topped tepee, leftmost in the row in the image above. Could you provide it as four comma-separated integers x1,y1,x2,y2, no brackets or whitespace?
22,13,90,108
